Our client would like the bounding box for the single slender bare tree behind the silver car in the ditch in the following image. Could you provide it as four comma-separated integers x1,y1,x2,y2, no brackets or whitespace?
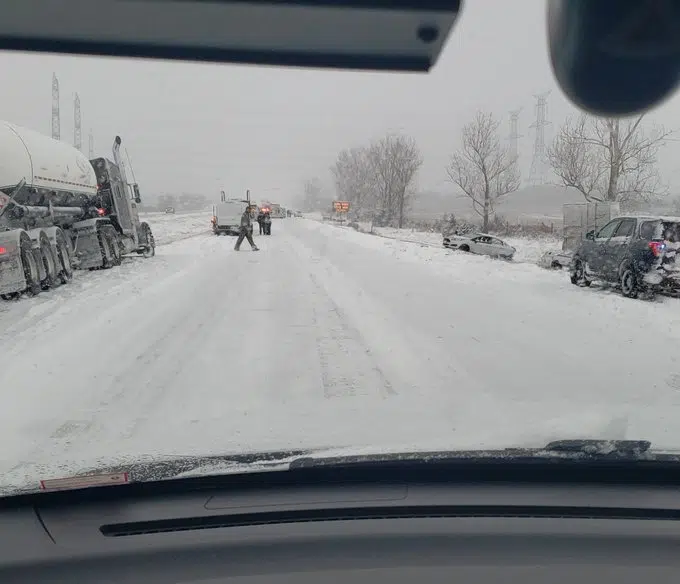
447,112,520,231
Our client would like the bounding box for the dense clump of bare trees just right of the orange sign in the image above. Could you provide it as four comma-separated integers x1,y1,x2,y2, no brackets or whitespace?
331,134,423,227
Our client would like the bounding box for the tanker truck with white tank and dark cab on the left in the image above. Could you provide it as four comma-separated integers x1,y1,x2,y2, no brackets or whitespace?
0,121,155,300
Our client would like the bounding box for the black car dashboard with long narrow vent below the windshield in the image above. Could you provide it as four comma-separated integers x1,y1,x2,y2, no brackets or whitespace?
0,461,680,584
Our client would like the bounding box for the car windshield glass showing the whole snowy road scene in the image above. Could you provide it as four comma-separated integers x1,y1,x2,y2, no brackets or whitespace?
0,0,680,492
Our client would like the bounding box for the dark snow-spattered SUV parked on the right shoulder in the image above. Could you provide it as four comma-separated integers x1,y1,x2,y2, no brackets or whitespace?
570,217,680,298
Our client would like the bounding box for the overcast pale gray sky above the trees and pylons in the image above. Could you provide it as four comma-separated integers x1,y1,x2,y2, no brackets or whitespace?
0,0,680,208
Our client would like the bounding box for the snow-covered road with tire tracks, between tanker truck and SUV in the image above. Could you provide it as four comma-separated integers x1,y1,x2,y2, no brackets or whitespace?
0,214,680,484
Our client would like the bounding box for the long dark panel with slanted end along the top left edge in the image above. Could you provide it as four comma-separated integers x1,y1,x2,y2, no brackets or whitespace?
0,0,462,72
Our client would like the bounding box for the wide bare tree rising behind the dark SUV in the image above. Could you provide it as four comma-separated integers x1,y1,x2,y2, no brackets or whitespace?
548,114,671,207
